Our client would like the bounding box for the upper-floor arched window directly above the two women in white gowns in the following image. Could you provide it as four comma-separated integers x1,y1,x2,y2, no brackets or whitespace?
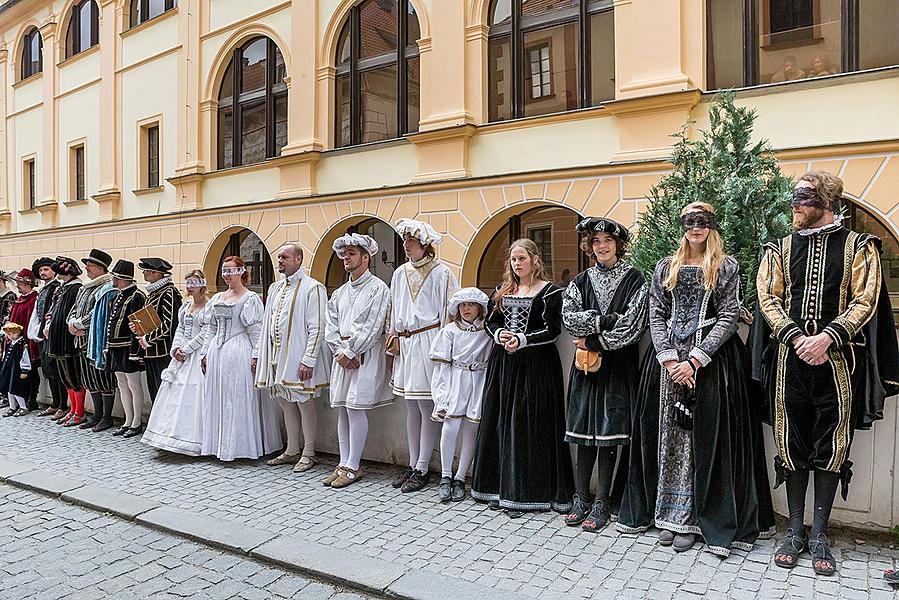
218,37,287,169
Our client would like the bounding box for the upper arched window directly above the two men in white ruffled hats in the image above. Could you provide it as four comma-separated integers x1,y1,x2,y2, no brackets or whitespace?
334,0,421,147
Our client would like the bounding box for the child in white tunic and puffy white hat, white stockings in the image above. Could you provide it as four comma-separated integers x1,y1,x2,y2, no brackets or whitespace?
430,288,493,502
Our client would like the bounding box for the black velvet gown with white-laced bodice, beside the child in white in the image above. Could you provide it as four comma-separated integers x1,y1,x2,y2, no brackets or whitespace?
471,283,574,512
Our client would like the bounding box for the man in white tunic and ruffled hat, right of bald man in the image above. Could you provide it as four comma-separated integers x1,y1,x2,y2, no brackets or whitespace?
322,233,393,488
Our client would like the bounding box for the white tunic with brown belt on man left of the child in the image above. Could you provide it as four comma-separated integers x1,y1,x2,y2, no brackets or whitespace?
390,258,459,400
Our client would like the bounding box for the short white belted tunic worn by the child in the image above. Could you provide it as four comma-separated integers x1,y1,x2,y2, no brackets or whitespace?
430,321,493,423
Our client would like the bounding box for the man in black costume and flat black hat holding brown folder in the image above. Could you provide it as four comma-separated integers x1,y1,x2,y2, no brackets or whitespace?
132,258,181,402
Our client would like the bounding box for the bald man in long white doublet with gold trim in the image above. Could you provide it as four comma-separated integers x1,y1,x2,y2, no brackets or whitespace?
256,244,330,473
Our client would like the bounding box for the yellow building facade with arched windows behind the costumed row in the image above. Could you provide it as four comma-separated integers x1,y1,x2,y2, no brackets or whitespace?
0,0,899,526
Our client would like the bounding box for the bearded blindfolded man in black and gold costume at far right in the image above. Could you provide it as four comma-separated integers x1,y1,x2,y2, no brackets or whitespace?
752,171,899,575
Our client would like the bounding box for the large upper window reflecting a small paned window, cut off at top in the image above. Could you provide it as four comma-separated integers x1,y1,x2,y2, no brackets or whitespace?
487,0,615,121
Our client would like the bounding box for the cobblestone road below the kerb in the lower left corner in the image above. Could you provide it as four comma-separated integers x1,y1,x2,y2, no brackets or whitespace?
0,485,370,600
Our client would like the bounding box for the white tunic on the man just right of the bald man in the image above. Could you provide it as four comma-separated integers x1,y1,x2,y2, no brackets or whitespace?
325,271,393,410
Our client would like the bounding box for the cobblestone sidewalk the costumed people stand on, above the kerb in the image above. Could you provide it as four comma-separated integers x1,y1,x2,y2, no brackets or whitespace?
0,415,899,600
